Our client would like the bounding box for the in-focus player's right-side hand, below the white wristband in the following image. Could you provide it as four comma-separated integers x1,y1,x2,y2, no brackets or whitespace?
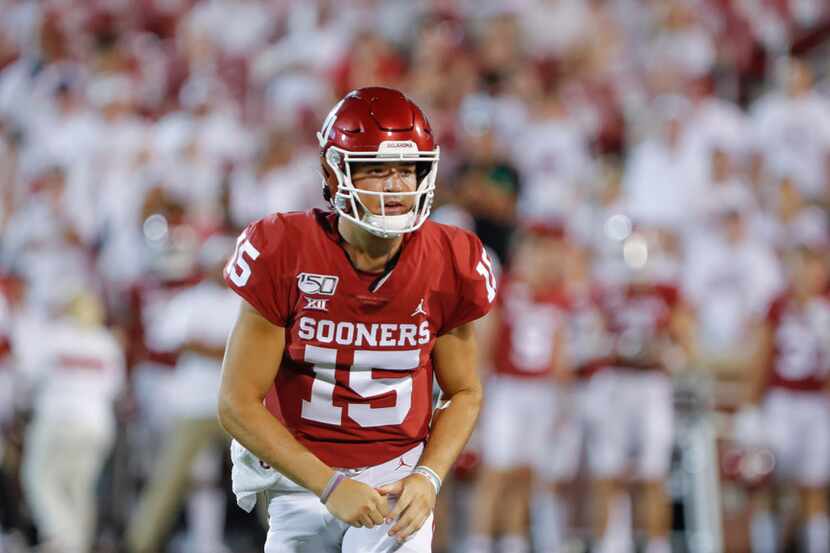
378,474,436,542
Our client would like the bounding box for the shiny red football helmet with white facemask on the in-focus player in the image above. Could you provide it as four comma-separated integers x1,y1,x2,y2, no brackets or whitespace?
317,87,439,238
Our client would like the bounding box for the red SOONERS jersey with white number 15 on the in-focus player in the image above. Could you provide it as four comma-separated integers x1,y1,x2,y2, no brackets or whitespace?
225,210,496,468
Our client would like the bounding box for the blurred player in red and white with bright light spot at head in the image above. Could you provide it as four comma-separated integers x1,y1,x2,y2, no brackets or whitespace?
586,227,690,553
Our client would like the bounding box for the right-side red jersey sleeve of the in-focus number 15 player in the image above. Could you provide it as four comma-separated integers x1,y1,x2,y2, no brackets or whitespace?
439,227,497,335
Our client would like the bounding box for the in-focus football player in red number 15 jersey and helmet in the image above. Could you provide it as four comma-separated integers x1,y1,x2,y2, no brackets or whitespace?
218,87,496,553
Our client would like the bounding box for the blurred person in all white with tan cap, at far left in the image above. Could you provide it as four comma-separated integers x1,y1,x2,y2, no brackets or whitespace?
14,289,125,553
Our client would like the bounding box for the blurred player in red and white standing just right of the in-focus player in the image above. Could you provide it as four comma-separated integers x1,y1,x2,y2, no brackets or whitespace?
465,224,567,553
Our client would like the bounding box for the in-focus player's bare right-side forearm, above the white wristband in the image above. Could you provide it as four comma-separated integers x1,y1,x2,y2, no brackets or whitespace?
419,387,482,480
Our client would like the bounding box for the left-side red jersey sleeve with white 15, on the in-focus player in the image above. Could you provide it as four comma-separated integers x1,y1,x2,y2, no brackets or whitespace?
224,214,290,327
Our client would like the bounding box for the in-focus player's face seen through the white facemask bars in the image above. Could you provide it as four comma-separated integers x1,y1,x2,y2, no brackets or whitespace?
352,162,418,215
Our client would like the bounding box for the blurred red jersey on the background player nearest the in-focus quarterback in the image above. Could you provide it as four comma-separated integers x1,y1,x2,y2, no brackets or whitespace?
493,279,567,378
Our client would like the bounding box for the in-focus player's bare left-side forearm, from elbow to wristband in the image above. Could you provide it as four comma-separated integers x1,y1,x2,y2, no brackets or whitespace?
219,397,334,495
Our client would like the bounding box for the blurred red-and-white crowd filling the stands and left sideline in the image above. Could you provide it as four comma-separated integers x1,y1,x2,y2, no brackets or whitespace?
0,0,830,553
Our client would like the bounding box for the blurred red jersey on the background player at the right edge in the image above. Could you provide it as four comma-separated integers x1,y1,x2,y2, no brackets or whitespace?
767,296,830,391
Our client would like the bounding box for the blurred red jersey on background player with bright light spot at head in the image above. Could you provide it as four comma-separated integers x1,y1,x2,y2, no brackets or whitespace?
599,285,679,370
